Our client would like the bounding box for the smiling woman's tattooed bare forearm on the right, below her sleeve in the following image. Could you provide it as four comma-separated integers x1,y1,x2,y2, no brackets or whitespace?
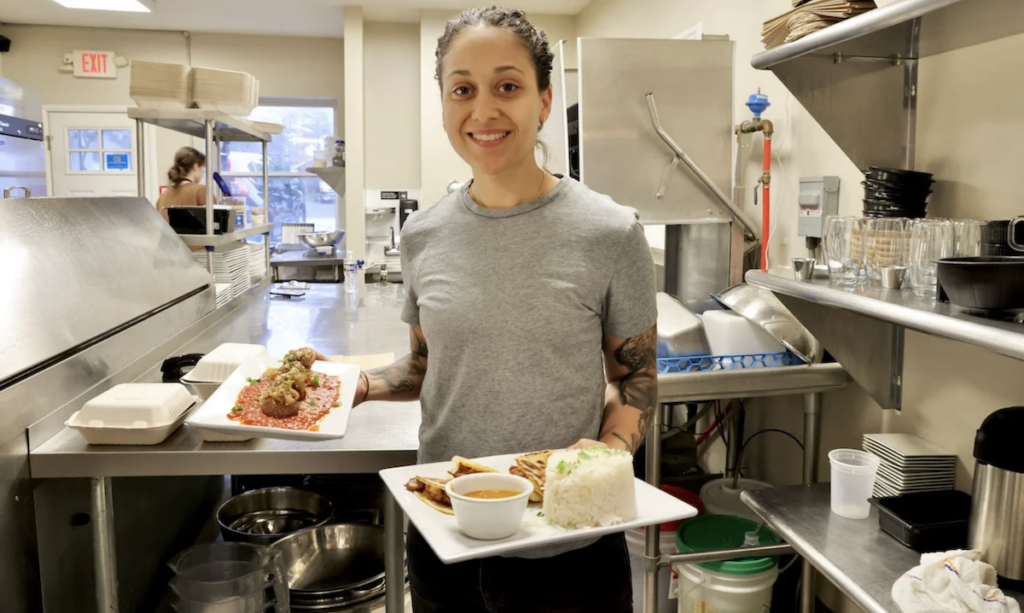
600,326,657,453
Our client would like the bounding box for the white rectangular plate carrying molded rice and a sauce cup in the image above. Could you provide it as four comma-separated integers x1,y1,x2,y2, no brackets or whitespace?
381,453,697,564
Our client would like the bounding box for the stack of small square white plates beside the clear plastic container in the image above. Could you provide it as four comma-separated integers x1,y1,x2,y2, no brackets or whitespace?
863,434,956,497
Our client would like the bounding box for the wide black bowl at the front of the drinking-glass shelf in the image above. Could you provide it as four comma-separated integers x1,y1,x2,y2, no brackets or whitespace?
938,257,1024,310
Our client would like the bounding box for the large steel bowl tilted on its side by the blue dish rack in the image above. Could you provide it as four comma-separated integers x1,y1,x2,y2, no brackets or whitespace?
712,283,824,364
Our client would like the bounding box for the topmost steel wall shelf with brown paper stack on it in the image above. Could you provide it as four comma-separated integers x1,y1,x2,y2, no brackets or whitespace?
751,0,1024,70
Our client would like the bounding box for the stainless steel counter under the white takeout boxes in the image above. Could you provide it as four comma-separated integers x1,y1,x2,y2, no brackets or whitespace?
30,283,420,479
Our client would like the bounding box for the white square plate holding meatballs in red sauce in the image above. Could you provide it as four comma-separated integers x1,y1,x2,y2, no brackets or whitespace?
185,357,359,441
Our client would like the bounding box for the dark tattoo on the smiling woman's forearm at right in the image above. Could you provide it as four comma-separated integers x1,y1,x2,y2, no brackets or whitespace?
610,329,657,452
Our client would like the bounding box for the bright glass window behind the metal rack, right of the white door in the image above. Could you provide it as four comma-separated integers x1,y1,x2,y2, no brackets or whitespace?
220,102,338,240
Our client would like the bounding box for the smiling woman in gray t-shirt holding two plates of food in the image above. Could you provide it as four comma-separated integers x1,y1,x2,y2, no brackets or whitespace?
356,7,657,613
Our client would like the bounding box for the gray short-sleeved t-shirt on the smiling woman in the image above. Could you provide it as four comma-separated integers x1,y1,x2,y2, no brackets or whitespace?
401,178,657,464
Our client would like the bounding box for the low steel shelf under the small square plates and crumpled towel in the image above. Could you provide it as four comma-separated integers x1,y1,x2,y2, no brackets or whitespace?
740,483,1021,613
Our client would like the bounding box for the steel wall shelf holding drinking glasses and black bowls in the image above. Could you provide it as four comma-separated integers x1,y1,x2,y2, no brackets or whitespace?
746,270,1024,360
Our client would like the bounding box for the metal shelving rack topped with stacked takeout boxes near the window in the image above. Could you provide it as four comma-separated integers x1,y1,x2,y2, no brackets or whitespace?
128,107,273,274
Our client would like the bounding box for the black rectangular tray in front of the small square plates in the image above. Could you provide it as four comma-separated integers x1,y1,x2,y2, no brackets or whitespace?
870,489,971,554
